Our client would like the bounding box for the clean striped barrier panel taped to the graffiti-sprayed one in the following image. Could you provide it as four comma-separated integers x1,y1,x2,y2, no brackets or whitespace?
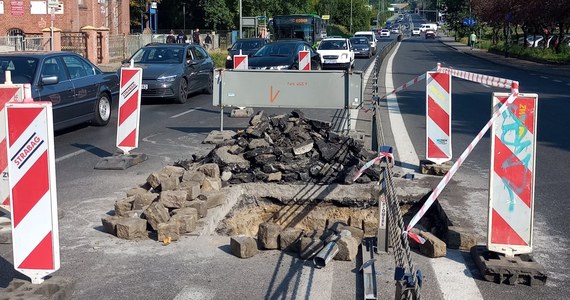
426,72,452,164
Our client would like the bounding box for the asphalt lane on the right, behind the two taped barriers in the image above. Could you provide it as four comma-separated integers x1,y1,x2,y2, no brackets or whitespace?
378,36,570,299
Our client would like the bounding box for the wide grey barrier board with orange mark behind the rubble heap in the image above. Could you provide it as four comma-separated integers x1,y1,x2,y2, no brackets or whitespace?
213,70,364,109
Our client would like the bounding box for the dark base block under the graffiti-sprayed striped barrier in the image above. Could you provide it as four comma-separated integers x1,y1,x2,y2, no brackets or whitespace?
471,245,547,286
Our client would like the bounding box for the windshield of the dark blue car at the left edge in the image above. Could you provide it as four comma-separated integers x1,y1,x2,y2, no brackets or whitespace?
0,56,38,83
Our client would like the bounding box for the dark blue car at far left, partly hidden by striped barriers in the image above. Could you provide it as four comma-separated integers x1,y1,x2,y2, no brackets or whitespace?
0,51,119,130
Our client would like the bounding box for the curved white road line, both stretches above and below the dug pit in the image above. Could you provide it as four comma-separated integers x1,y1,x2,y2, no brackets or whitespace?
386,43,483,300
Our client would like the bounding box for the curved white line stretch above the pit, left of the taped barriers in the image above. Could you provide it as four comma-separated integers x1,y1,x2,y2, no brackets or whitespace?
385,43,420,172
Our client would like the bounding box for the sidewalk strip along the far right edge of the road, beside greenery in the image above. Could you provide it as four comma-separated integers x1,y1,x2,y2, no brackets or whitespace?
439,35,570,79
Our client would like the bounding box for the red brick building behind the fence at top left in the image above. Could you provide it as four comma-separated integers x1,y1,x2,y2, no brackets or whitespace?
0,0,130,36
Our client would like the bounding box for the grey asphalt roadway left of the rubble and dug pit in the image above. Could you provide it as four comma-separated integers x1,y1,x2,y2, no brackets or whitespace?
0,41,387,299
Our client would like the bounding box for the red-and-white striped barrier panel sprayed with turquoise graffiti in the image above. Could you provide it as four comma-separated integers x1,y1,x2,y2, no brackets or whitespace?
487,93,538,257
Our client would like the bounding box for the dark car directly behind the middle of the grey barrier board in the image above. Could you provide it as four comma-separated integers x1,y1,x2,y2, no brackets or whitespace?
248,40,322,70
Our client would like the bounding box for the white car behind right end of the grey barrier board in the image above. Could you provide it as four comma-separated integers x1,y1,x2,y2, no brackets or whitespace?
317,38,354,70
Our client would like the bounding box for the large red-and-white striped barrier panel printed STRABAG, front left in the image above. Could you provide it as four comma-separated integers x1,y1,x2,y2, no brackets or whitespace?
5,102,60,284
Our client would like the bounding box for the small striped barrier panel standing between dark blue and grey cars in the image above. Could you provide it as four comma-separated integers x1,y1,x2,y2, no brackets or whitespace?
117,63,142,154
